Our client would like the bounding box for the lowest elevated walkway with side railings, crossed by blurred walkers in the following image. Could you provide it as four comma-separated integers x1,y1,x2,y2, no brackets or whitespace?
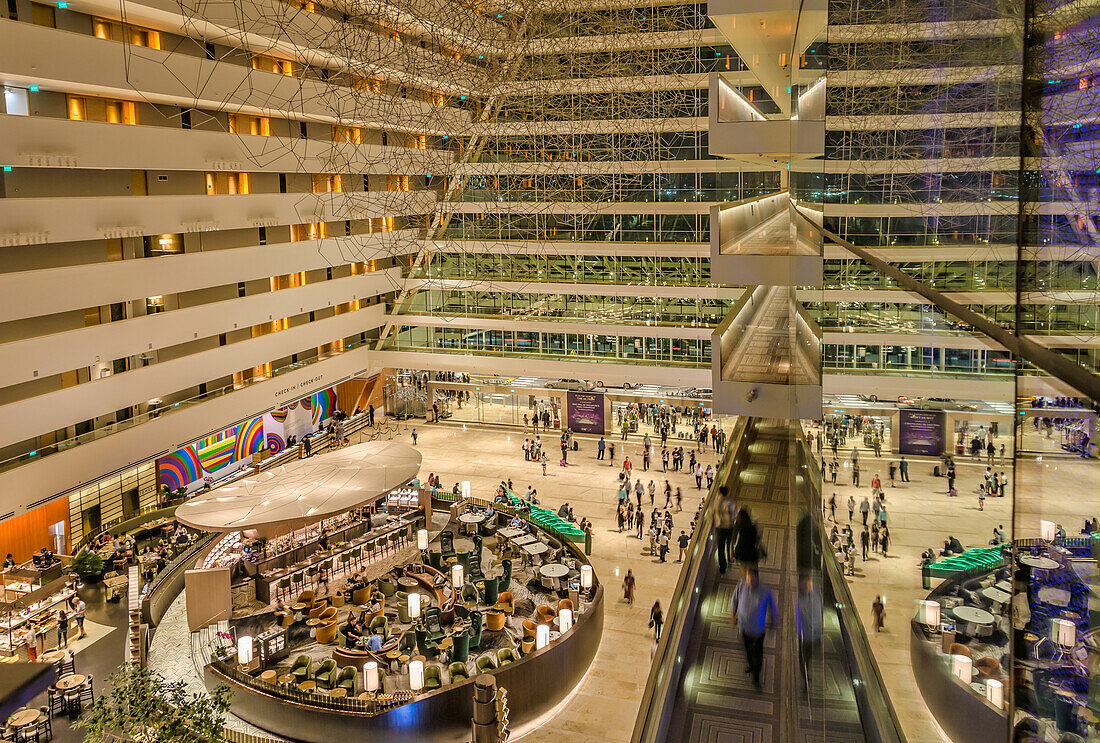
633,418,904,743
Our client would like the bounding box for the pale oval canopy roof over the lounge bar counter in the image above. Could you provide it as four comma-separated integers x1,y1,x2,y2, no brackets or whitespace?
176,441,421,536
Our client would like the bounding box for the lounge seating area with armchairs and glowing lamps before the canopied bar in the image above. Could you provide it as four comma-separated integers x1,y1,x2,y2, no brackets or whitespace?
231,510,594,699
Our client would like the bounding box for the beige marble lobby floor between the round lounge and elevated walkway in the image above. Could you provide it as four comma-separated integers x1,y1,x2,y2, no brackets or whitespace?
411,420,717,743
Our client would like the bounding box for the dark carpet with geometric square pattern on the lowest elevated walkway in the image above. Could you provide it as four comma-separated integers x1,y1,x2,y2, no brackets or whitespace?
666,426,864,743
